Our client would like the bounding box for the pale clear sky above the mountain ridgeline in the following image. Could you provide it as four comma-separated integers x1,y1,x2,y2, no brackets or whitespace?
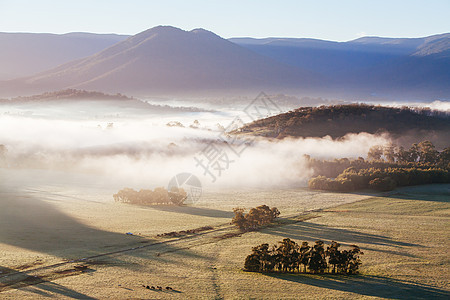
0,0,450,41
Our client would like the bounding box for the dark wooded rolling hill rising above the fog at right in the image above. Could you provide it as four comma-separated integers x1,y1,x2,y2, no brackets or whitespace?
238,104,450,145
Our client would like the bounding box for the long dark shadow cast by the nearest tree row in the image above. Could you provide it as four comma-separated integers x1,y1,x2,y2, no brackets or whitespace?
265,274,450,299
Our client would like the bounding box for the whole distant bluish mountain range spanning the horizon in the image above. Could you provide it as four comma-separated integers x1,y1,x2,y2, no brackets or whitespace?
0,26,450,100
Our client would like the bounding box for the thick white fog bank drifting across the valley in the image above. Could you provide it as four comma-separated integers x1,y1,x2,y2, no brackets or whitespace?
0,101,390,189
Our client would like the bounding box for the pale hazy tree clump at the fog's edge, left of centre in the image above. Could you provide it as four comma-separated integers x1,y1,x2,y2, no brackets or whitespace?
113,187,187,205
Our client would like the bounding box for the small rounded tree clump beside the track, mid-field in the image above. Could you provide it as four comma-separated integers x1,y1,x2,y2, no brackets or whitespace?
231,205,280,231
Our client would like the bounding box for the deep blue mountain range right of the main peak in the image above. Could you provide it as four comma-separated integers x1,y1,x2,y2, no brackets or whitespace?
230,33,450,99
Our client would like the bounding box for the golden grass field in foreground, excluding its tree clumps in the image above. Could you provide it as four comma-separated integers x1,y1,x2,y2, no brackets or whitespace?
0,168,450,299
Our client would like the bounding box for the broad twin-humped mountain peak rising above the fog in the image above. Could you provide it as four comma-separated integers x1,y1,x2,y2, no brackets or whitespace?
15,26,315,93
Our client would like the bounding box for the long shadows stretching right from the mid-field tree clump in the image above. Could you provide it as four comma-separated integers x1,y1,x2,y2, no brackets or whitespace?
263,222,421,247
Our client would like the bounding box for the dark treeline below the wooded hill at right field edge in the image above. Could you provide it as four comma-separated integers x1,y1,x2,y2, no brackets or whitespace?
308,141,450,192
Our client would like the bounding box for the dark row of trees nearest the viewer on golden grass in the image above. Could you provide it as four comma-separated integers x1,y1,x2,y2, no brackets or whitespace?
244,238,364,274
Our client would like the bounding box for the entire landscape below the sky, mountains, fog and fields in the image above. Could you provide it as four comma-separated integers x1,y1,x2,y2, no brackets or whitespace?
0,17,450,299
